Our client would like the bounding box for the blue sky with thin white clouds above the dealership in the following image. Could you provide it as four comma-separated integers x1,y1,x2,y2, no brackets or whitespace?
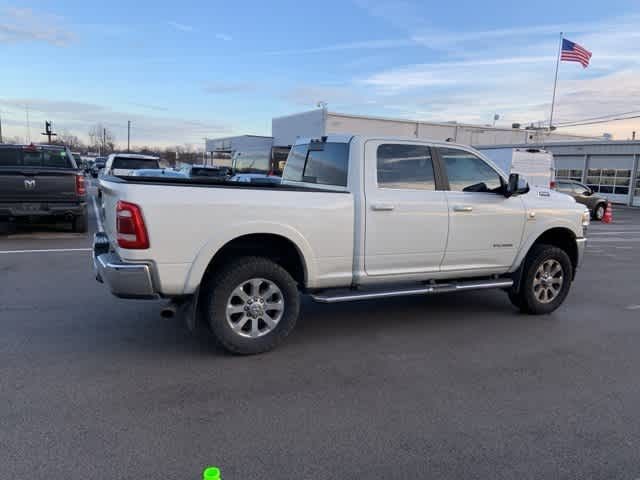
0,0,640,146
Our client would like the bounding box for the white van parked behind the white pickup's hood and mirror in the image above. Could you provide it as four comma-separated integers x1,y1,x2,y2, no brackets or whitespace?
476,147,556,188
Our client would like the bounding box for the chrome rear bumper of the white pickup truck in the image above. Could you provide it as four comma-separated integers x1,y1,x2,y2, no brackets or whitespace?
93,232,158,298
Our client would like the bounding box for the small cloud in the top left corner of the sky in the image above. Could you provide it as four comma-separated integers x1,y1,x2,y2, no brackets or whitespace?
0,8,76,47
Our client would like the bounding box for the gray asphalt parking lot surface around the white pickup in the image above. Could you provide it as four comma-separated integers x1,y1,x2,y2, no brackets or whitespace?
0,188,640,480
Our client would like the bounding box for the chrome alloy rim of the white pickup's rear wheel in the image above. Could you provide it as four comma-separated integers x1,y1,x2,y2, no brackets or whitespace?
226,278,284,338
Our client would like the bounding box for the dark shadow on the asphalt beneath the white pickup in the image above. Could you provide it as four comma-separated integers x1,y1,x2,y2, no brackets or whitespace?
109,292,530,357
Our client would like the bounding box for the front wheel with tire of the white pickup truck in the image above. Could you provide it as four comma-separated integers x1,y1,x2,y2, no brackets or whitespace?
509,245,573,315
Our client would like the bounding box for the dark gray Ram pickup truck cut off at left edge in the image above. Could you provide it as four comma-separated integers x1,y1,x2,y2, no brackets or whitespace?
0,144,87,233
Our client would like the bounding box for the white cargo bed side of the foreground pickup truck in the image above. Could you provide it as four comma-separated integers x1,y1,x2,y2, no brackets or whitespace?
100,176,355,295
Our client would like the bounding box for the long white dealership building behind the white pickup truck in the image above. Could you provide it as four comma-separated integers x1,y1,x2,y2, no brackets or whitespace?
206,108,640,206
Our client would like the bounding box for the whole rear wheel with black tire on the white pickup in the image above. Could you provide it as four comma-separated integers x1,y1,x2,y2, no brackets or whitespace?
205,257,300,355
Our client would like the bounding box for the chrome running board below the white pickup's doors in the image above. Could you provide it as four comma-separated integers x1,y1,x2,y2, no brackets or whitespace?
311,279,513,303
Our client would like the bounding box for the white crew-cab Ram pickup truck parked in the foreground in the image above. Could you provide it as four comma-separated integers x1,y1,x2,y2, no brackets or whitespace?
94,136,589,354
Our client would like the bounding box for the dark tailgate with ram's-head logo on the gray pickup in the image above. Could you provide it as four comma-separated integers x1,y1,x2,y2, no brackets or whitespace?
0,167,80,202
